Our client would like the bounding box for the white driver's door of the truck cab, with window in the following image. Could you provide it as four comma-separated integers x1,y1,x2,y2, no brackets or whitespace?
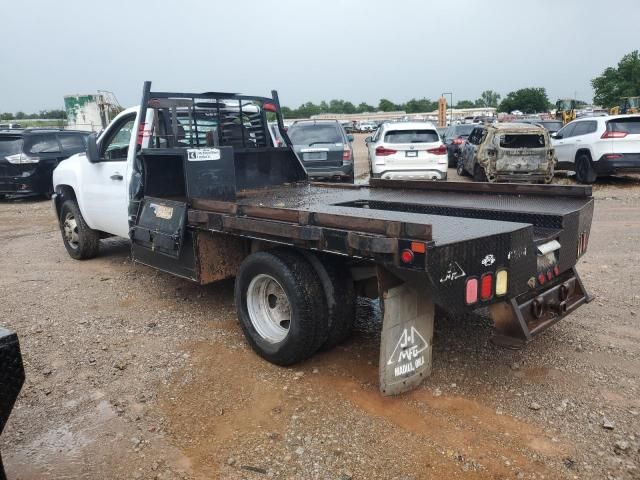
81,113,136,237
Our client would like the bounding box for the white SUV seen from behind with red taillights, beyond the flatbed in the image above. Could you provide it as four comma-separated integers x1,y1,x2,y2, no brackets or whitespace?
365,122,448,180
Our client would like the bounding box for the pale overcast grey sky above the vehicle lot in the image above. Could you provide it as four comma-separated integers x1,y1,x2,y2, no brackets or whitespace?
0,0,640,113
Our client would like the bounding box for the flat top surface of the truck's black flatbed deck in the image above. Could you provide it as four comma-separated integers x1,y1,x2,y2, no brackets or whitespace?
192,183,591,246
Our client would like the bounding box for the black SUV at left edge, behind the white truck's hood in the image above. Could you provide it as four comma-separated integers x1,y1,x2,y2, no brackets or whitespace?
0,128,89,198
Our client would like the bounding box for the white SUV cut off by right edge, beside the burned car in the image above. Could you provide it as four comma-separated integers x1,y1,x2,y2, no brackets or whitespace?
551,115,640,183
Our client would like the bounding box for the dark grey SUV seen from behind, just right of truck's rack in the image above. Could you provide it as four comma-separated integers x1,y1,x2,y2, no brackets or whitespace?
287,120,353,183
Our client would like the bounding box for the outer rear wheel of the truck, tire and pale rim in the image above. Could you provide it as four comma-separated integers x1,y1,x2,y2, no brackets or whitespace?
235,249,328,366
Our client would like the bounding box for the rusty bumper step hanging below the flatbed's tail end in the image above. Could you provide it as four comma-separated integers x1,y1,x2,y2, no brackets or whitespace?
489,269,593,347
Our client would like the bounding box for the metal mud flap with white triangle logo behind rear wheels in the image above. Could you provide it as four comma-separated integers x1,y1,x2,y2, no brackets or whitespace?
377,267,434,395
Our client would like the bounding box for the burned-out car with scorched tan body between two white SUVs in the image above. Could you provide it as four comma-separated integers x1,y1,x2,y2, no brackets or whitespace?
457,123,556,183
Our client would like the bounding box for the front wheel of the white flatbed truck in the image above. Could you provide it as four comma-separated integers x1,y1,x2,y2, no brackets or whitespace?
60,200,100,260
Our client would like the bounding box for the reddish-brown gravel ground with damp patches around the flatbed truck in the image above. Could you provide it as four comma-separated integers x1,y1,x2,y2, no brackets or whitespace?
0,136,640,480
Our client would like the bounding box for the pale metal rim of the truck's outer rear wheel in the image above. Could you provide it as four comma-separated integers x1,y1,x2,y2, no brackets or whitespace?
247,274,291,343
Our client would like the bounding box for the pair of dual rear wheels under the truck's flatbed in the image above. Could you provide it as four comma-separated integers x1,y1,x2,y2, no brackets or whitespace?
235,248,355,365
